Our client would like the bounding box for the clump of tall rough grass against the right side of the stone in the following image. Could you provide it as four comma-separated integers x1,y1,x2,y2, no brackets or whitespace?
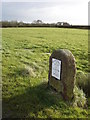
73,71,90,108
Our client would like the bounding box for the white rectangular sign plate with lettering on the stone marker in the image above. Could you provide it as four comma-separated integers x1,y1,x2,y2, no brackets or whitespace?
52,58,61,80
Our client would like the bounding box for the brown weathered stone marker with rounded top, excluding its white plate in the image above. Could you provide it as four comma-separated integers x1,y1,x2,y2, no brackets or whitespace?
48,49,76,100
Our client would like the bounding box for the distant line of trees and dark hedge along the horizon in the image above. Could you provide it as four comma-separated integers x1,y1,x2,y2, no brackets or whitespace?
0,20,90,29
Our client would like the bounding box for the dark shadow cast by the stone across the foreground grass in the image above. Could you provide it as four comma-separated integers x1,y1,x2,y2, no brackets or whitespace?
3,83,63,118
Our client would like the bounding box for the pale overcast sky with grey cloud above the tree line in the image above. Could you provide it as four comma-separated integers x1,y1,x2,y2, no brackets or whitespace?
2,0,88,25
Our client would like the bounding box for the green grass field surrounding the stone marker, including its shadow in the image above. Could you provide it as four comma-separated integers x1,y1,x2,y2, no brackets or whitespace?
2,28,90,118
